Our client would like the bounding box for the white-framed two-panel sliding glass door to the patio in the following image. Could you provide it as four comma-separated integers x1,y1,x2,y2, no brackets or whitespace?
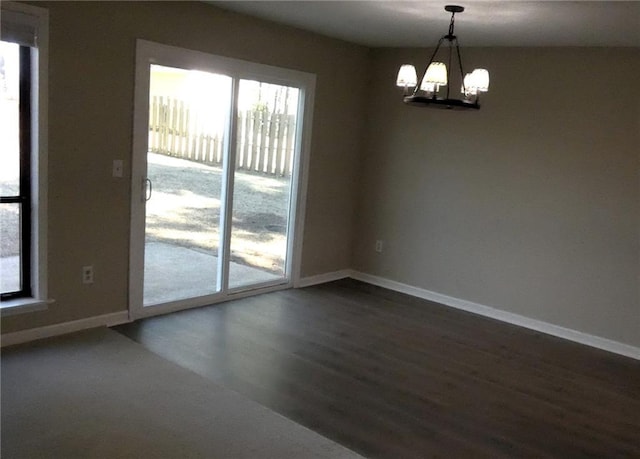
130,41,314,318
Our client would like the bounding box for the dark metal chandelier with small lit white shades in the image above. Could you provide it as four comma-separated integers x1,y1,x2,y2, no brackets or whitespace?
396,5,489,110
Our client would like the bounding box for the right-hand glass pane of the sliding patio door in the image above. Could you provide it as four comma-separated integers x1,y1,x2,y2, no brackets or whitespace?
229,80,299,288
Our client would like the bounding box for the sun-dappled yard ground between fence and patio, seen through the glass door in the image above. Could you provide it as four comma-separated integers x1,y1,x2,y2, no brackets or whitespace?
146,153,290,274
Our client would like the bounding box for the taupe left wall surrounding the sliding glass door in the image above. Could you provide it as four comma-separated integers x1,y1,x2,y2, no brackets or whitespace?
2,2,368,333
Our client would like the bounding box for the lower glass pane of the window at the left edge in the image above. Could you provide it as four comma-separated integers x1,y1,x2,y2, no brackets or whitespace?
0,204,22,293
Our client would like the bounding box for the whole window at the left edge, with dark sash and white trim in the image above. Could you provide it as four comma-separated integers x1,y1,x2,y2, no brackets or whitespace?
0,3,47,315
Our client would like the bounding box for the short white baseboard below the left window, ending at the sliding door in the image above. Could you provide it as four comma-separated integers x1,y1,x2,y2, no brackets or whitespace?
0,311,129,347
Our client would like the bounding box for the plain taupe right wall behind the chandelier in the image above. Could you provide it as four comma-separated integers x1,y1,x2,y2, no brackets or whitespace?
354,48,640,346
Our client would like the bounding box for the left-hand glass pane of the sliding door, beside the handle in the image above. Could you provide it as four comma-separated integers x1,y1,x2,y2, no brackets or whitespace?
144,65,231,306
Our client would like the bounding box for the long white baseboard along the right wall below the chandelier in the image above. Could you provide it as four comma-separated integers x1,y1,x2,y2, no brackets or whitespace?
350,271,640,360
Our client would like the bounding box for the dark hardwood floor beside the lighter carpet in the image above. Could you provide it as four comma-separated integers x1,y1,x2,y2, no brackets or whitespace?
116,280,640,459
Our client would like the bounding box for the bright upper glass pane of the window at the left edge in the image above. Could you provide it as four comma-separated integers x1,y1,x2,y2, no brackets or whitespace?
0,41,20,196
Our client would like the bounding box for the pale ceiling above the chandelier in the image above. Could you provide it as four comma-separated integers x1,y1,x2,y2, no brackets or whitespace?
207,0,640,47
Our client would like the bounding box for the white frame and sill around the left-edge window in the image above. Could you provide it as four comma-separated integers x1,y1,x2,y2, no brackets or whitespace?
0,2,53,317
